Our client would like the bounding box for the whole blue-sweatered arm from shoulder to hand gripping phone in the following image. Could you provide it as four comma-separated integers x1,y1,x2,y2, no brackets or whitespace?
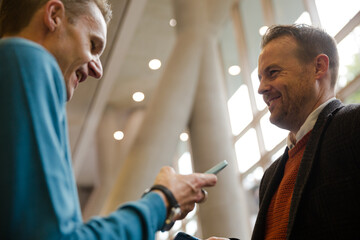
0,40,216,240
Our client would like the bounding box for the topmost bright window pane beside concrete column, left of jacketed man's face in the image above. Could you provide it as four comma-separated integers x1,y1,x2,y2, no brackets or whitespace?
228,84,253,135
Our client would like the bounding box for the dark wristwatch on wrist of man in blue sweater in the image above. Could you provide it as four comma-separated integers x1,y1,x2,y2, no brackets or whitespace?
143,185,181,232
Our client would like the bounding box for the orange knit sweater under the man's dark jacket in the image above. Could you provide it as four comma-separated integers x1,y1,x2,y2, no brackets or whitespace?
265,131,311,239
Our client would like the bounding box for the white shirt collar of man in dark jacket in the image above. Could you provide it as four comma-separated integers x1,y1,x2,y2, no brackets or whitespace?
286,97,335,149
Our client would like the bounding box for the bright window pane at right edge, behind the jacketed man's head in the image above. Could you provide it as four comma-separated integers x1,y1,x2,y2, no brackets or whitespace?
337,26,360,89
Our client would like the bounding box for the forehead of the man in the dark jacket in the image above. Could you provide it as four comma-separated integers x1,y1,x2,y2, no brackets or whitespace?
259,36,298,70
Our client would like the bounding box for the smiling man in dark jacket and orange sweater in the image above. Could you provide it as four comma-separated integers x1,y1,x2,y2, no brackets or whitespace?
252,25,360,240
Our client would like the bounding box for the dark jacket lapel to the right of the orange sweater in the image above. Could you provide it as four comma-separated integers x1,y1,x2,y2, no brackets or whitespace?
287,100,343,239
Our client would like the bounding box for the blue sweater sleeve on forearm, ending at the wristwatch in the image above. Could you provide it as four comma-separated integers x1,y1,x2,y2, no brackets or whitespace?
73,193,166,240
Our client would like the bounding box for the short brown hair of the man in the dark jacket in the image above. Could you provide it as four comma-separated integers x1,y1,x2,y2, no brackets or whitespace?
261,24,339,87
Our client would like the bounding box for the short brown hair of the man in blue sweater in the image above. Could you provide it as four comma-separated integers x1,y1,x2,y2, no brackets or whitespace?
0,0,112,38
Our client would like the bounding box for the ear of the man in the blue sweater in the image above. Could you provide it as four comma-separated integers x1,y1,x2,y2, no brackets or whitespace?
44,0,65,32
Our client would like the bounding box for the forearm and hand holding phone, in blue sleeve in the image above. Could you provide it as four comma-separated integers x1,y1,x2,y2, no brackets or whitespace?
73,167,217,239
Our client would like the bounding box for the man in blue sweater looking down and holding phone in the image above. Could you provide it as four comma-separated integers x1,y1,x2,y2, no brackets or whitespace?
0,0,216,240
